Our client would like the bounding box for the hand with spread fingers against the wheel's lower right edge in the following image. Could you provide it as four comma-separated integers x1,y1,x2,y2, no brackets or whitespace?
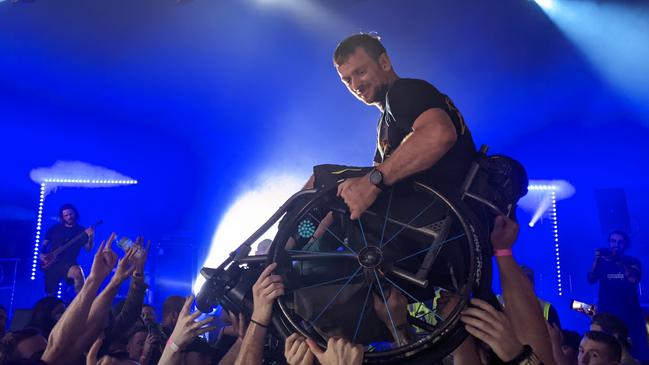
460,298,523,362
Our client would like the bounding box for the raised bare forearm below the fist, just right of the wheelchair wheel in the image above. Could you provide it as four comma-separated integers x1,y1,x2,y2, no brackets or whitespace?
496,256,555,365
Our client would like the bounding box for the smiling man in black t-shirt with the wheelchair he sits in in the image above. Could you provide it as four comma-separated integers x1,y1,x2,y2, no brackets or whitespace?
199,34,527,362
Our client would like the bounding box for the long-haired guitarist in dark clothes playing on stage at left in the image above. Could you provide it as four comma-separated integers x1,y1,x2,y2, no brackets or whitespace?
41,204,95,296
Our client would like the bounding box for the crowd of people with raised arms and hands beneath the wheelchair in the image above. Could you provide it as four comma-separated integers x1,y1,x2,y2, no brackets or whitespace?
0,216,640,365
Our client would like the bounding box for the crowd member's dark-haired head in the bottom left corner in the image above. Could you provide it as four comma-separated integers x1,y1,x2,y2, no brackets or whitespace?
0,327,47,364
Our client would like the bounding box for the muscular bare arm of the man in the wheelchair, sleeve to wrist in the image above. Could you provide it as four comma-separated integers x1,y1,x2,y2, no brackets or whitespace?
378,108,457,185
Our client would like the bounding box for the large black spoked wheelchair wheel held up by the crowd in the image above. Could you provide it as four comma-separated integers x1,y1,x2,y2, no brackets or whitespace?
270,183,491,363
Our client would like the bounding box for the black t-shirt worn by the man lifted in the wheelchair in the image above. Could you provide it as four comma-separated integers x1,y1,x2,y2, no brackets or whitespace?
374,79,476,193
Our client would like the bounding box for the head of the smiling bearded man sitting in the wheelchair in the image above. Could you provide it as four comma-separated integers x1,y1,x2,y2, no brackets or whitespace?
333,33,398,105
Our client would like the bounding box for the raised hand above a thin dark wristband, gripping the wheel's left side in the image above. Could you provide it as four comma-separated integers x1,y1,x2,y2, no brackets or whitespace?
252,262,284,326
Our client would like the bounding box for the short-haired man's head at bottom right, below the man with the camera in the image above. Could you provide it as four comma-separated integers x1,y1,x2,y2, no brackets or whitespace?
578,331,622,365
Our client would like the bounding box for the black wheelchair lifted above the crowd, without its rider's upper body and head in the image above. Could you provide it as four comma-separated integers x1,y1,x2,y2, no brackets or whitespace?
196,146,527,364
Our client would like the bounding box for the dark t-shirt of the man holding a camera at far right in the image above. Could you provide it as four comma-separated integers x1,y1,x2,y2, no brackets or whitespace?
596,255,642,318
